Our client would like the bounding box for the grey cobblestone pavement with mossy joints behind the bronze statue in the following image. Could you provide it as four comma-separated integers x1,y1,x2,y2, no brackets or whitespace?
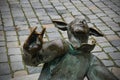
0,0,120,80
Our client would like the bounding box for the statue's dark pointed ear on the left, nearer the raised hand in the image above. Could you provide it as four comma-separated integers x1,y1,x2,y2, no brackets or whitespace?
52,21,68,31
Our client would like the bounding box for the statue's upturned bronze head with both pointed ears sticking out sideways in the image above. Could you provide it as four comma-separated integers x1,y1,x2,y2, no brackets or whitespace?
53,18,103,48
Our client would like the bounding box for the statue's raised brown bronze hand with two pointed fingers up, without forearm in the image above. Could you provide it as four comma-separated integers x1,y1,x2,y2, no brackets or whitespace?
23,27,45,53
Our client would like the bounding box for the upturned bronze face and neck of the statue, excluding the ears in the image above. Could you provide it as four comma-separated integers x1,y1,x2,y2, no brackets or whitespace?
67,19,89,48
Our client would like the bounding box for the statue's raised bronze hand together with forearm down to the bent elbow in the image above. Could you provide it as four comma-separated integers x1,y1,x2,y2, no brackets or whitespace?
23,27,45,66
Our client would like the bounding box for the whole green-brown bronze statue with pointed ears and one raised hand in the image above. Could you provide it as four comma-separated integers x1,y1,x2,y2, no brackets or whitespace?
23,19,118,80
